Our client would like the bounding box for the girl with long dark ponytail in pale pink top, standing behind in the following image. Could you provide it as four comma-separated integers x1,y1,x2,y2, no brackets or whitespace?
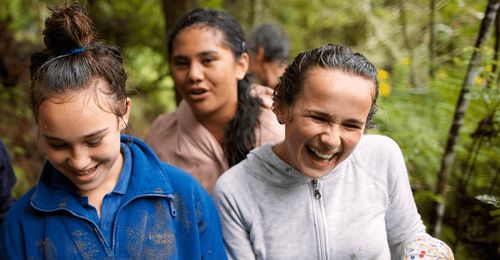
146,9,284,193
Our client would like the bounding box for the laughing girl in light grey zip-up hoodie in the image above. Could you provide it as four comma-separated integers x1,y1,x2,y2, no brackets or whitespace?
214,44,453,259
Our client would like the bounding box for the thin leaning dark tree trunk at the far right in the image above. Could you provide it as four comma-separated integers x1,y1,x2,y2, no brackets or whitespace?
431,0,500,237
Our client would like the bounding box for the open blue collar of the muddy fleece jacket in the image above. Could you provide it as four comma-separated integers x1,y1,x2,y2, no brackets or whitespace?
31,135,173,212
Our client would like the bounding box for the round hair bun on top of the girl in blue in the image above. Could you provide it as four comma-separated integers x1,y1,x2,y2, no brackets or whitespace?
43,3,95,53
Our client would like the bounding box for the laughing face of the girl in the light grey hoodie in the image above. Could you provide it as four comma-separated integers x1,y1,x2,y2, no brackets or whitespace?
274,68,375,179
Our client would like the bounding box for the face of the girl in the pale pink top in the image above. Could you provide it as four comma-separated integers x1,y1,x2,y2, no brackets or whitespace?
171,25,248,119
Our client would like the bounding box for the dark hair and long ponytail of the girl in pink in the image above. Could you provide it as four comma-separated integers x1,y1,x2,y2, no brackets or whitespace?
168,9,262,166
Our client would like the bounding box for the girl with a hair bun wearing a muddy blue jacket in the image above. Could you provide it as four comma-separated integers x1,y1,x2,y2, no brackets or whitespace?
0,3,226,259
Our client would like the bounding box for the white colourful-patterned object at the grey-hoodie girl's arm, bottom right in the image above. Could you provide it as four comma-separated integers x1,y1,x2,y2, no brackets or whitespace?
403,236,455,260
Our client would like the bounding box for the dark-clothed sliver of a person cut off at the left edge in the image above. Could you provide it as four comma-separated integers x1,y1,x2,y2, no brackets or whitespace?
0,140,16,226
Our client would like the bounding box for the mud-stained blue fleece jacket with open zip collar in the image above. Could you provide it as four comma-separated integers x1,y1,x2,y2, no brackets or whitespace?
0,135,226,259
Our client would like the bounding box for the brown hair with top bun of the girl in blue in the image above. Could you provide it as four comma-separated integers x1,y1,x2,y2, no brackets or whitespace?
30,3,127,120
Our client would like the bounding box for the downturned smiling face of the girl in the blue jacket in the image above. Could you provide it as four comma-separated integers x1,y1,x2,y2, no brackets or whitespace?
38,80,130,196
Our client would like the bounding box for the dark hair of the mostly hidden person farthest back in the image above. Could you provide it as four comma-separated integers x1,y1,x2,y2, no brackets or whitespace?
248,24,290,63
